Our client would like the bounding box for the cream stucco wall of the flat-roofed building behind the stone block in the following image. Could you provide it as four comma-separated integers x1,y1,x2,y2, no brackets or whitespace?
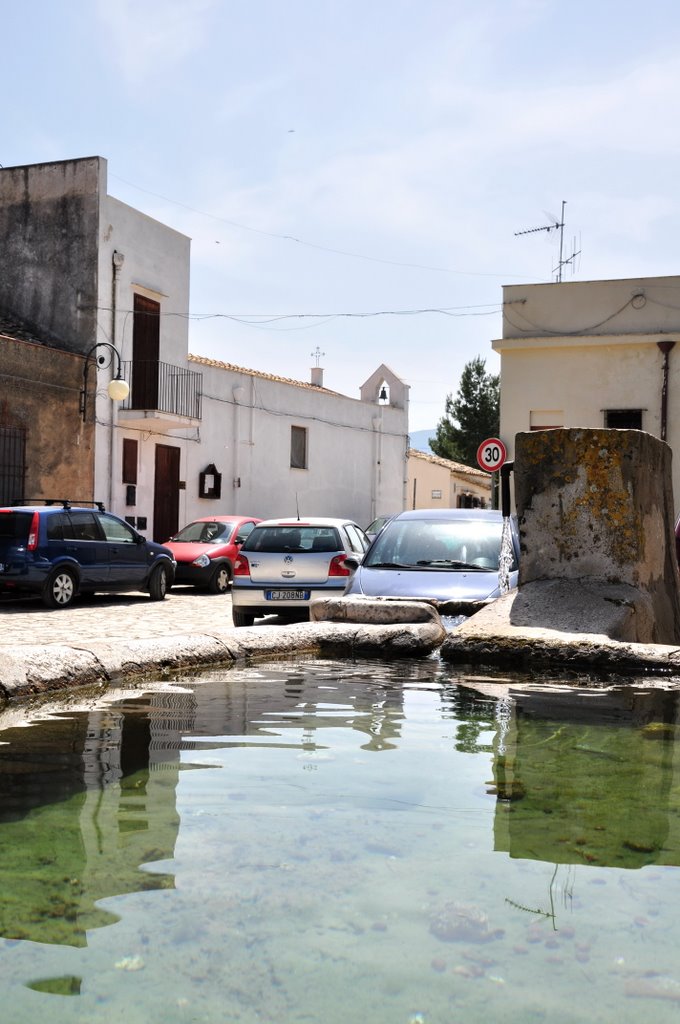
493,278,680,510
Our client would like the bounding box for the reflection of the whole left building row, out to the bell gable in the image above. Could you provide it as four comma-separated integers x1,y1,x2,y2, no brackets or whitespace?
0,665,403,945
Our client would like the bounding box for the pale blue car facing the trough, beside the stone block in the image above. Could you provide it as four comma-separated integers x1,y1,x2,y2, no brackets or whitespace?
345,509,519,615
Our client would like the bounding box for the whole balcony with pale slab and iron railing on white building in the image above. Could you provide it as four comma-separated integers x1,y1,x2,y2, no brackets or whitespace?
118,359,203,429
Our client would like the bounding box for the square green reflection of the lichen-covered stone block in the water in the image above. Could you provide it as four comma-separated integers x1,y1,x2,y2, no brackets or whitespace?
491,686,680,868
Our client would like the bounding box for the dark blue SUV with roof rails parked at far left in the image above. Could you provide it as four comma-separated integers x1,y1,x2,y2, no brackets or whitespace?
0,501,175,608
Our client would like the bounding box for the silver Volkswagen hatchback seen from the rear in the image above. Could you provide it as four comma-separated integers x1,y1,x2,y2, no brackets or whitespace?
231,518,369,626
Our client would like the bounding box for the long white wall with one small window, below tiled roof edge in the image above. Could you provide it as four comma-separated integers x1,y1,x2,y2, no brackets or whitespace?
175,357,408,526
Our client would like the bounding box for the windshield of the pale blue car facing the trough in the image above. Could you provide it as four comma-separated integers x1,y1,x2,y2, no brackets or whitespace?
364,519,516,571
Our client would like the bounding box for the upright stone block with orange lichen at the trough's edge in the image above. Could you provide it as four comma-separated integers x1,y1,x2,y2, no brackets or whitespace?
514,429,680,643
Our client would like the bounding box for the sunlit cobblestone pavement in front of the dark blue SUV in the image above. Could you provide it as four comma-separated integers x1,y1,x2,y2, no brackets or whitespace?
0,587,244,647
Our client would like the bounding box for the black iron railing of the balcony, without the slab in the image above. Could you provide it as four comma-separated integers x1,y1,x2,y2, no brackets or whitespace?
121,359,203,420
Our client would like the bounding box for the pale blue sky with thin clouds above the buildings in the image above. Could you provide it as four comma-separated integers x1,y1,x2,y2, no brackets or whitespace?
0,0,680,431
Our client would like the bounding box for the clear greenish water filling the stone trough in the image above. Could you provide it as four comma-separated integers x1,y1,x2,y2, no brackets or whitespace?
0,658,680,1024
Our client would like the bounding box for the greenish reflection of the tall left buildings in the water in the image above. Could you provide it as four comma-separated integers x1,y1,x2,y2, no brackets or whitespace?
0,708,185,945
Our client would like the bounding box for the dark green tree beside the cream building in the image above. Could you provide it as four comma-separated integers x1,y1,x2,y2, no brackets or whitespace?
430,356,501,466
